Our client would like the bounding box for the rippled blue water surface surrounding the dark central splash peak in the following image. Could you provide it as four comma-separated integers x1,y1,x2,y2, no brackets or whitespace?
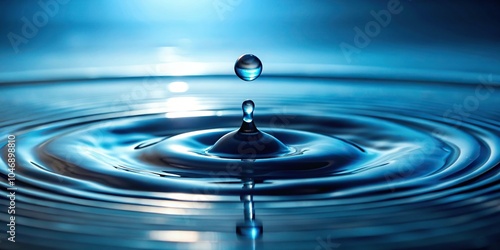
0,77,500,249
